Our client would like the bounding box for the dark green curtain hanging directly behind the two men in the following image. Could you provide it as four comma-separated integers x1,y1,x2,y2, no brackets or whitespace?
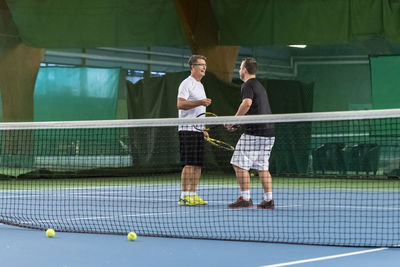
128,72,313,174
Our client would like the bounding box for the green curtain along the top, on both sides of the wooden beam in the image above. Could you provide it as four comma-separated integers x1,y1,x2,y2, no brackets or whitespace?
6,0,400,48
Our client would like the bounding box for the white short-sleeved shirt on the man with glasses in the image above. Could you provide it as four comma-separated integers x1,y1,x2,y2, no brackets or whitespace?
178,76,207,132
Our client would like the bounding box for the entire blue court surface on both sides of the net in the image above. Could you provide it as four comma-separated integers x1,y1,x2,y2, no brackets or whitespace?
0,184,400,267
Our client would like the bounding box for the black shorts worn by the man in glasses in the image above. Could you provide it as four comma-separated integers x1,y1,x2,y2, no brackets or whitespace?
179,131,204,167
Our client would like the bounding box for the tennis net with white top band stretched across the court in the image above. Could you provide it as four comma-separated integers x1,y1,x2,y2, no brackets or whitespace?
0,110,400,247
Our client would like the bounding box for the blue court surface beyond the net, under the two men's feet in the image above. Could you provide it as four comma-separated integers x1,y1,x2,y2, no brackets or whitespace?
0,184,400,247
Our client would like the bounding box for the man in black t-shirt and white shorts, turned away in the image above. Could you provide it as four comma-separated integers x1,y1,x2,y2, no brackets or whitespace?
226,58,275,209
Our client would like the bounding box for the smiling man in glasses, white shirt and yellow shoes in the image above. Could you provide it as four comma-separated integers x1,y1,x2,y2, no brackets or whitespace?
177,55,211,206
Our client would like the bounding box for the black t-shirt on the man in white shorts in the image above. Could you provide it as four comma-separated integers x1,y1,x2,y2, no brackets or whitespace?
241,78,275,137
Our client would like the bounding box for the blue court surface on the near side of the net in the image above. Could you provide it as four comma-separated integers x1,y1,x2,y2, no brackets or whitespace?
0,225,400,267
